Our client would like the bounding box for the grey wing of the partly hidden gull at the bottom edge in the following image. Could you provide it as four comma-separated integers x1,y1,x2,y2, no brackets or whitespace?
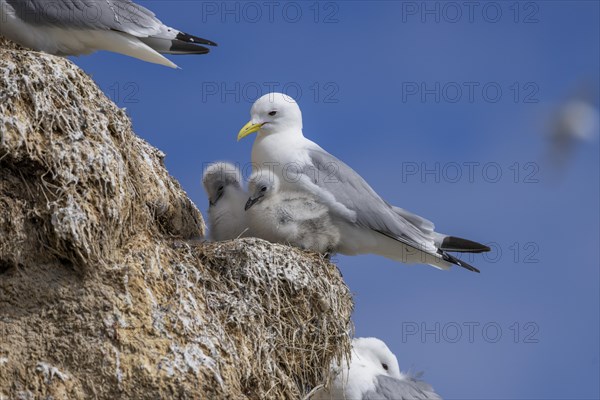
362,375,442,400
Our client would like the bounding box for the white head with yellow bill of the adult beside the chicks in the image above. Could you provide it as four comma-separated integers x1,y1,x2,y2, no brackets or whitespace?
238,92,302,140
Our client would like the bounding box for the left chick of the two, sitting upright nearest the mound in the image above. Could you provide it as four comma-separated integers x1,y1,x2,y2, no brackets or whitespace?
202,162,248,241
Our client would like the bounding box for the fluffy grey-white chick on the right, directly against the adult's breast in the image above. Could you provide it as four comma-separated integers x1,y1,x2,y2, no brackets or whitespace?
245,169,340,253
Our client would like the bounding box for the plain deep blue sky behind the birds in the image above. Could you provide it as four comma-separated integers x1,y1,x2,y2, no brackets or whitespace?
75,0,600,399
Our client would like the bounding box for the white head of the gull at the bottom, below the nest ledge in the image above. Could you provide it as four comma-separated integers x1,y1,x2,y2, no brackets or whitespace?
350,338,404,379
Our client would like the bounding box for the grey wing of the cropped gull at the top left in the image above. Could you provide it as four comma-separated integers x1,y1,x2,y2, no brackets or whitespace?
5,0,163,37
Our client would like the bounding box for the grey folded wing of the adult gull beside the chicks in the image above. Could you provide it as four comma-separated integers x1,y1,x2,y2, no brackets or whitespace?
302,146,433,250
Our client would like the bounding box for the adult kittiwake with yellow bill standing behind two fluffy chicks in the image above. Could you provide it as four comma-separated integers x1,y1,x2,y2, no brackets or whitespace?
238,93,490,272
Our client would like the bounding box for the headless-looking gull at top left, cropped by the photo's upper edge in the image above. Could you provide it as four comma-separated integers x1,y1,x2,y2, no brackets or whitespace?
0,0,217,68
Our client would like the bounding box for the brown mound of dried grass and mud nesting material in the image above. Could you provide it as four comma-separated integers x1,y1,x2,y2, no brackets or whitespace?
0,39,352,400
